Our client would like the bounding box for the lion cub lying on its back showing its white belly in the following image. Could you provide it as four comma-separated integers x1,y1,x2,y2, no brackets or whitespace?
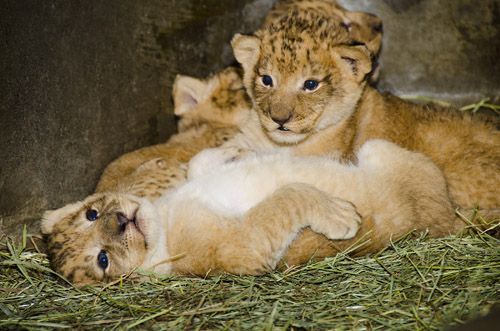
42,140,461,284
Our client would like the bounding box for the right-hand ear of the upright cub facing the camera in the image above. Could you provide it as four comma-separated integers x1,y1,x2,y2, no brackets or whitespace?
334,45,372,82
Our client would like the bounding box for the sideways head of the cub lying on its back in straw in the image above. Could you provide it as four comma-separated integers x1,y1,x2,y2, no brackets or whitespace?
41,193,161,285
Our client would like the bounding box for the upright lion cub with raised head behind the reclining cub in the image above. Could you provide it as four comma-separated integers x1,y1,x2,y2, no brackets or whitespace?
226,4,500,209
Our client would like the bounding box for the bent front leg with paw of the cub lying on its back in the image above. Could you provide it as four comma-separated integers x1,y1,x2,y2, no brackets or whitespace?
217,183,361,275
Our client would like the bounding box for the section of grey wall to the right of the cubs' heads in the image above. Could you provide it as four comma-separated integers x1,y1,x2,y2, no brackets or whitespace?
339,0,500,103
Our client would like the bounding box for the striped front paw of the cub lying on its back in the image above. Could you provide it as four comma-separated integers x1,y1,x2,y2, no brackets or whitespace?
310,198,361,240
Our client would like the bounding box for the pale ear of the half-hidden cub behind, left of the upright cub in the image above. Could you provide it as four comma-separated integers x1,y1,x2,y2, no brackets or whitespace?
172,75,209,116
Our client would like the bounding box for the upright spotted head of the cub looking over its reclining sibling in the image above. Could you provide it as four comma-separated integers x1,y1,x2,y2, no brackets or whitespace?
232,7,374,144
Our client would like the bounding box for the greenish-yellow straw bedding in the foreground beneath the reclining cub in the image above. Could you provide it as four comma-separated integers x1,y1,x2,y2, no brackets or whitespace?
0,228,500,330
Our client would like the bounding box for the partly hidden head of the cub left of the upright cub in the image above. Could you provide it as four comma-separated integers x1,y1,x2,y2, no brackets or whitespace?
173,67,251,131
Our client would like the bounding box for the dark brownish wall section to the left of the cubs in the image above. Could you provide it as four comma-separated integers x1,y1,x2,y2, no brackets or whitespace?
0,0,272,239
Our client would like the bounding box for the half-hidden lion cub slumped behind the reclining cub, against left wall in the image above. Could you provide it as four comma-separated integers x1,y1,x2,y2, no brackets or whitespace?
96,67,250,200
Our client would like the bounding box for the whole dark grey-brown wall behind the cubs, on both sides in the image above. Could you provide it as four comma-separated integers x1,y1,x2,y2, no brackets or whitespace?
0,0,500,239
